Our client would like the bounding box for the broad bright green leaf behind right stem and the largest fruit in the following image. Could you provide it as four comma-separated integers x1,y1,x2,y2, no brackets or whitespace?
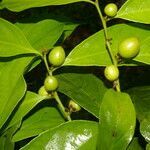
64,24,150,66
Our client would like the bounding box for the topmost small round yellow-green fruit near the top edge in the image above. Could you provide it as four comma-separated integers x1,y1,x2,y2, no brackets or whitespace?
104,3,118,17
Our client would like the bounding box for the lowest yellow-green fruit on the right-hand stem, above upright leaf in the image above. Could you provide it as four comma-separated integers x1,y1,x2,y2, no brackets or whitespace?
104,65,119,81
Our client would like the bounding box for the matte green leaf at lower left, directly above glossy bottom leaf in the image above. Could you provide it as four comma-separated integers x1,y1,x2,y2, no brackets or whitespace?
13,107,64,142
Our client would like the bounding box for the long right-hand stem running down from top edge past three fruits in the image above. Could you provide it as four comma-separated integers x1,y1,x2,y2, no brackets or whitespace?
94,0,120,92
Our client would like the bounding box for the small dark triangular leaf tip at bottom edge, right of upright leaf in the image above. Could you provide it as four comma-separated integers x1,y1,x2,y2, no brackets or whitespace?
127,138,144,150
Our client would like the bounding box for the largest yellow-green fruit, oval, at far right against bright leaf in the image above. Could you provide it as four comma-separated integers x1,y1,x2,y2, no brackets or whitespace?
118,37,140,58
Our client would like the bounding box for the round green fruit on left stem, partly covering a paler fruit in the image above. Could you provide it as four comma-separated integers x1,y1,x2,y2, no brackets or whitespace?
44,76,58,92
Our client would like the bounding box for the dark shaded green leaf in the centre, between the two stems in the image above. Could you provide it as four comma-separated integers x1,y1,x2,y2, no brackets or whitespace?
57,73,106,118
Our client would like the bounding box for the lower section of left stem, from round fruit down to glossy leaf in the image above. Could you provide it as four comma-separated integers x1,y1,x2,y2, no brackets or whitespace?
54,92,71,121
